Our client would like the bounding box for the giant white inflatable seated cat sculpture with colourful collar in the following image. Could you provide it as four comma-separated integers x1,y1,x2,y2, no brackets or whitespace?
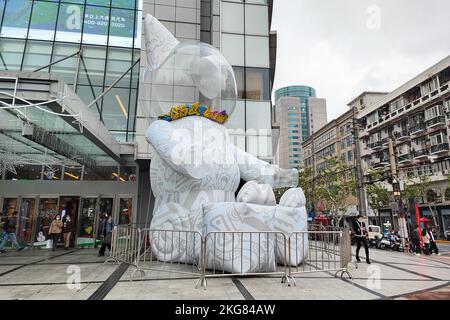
144,15,308,272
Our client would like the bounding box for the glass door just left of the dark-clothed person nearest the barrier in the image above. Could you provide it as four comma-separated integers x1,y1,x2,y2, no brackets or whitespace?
76,198,98,247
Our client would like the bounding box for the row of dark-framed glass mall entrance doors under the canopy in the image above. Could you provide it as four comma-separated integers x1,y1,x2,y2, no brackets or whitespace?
0,195,134,248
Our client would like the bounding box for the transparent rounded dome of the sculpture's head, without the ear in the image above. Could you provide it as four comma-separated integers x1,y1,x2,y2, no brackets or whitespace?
143,43,237,122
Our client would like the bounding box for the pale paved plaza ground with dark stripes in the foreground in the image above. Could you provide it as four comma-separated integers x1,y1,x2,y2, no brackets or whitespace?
0,245,450,300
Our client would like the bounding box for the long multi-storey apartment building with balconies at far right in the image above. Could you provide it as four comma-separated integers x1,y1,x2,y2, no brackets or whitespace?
354,56,450,233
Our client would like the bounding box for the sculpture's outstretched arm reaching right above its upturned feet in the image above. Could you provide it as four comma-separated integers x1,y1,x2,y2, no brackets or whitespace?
231,145,298,188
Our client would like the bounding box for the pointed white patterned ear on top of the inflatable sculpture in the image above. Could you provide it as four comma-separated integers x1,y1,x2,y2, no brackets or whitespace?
144,14,179,71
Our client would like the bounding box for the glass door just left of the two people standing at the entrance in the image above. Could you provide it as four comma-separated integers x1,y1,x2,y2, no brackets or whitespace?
34,198,58,247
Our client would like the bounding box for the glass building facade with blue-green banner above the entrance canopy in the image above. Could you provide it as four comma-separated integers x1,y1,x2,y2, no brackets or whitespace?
0,0,142,141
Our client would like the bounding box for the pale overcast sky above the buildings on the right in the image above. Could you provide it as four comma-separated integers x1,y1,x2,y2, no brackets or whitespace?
272,0,450,120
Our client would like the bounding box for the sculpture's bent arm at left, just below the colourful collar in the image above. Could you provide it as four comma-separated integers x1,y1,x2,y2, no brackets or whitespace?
145,120,209,179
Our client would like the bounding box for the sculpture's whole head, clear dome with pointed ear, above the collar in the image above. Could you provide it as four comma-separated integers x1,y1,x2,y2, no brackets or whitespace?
141,14,237,123
